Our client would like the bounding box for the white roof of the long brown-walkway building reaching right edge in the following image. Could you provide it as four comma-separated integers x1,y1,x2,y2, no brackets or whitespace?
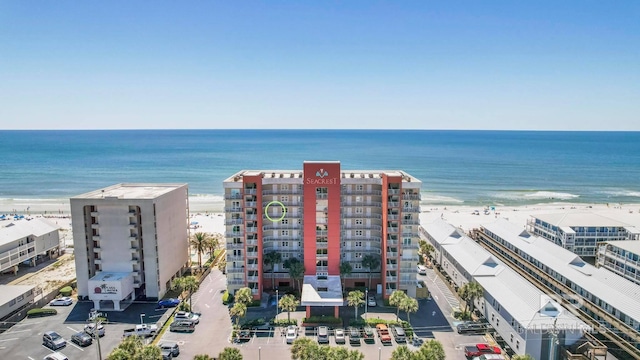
482,219,640,322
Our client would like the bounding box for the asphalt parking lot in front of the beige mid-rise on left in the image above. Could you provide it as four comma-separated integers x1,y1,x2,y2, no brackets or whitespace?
0,302,168,360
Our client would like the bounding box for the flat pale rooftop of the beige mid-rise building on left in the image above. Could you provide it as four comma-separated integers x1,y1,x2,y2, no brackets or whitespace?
71,183,187,200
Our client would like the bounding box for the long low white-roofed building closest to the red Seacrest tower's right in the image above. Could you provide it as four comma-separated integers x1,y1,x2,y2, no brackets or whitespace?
423,219,592,359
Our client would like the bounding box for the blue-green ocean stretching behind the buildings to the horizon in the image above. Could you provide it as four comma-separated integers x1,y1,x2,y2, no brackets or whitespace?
0,130,640,206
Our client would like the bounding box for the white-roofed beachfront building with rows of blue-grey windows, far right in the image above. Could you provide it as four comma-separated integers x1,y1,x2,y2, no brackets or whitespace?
527,212,640,257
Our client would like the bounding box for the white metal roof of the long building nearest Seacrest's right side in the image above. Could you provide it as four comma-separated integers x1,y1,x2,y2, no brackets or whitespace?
425,219,588,329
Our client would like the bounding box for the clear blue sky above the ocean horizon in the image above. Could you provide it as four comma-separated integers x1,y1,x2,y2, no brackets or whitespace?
0,0,640,130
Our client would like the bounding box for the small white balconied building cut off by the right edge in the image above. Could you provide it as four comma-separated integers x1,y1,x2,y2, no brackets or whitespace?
596,240,640,285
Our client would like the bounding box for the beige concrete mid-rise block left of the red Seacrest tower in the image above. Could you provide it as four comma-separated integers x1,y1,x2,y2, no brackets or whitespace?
71,184,189,310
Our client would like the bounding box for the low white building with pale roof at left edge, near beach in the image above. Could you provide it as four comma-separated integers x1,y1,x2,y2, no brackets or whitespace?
0,218,60,272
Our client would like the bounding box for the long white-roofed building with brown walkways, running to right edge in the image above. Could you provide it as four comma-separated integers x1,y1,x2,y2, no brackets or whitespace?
474,219,640,359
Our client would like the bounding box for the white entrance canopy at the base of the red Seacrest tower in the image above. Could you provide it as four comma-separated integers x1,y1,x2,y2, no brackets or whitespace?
300,275,344,306
